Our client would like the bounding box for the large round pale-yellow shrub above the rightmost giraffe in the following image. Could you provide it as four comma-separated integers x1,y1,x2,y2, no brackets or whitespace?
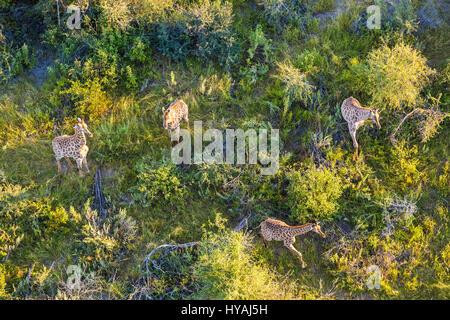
367,42,435,111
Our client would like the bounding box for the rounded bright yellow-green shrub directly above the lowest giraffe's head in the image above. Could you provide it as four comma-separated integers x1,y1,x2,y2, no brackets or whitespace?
288,167,344,222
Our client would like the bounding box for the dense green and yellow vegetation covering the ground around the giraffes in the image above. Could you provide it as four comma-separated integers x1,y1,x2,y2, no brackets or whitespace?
0,0,450,299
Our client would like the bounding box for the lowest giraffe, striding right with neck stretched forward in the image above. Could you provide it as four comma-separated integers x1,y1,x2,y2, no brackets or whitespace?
260,219,325,268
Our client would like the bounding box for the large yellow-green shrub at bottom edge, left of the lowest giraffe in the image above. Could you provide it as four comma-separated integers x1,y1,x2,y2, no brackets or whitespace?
192,216,294,300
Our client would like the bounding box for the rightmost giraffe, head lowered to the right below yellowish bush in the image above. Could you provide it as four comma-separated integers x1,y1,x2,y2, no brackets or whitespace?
341,97,381,160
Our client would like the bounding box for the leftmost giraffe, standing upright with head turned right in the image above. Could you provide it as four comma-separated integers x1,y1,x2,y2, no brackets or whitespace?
52,118,93,173
